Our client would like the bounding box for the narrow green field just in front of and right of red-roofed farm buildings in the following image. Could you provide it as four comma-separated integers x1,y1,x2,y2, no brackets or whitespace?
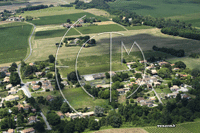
77,24,125,34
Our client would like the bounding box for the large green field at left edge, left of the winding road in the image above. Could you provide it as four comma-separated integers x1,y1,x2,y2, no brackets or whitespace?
0,23,32,63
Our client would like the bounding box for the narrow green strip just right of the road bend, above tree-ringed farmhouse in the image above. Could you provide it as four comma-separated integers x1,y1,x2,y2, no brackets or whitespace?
35,28,80,39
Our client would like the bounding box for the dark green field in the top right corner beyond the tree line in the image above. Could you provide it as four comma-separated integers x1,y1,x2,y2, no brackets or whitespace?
109,0,200,17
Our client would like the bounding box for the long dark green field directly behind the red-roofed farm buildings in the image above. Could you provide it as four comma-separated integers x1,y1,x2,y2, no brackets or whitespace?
30,12,108,25
